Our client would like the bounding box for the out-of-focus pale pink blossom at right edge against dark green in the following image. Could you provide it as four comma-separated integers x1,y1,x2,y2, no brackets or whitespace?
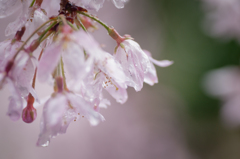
204,66,240,128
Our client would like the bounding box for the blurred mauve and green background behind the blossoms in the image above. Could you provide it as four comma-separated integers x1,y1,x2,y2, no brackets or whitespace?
0,0,240,159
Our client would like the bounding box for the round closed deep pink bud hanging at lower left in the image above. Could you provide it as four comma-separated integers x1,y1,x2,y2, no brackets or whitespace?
22,105,37,123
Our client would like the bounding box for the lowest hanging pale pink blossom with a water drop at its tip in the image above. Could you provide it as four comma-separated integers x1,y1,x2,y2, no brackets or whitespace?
37,79,105,146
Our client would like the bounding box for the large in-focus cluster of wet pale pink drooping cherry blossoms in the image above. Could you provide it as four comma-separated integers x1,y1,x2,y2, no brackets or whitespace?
0,0,172,146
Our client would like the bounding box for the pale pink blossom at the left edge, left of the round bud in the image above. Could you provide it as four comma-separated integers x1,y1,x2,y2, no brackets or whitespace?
0,52,38,120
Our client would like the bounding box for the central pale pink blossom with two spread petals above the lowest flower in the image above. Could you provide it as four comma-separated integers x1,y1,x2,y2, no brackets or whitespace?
38,26,94,82
